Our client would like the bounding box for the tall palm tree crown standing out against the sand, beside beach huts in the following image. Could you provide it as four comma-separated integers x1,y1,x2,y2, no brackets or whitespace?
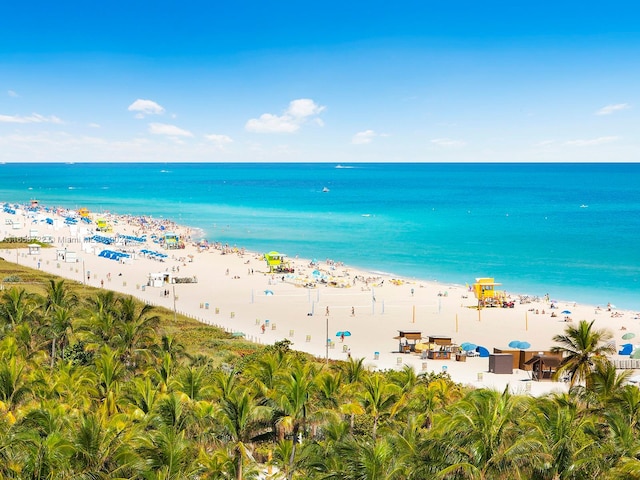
551,320,615,388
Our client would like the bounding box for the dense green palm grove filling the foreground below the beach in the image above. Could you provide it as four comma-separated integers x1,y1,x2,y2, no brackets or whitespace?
0,280,640,480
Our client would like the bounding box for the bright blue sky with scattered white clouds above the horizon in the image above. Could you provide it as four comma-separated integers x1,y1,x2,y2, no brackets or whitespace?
0,0,640,164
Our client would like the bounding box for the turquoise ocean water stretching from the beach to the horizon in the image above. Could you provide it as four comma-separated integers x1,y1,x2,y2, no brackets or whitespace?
0,163,640,311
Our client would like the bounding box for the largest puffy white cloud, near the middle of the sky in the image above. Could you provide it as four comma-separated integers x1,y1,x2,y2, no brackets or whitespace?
244,98,326,133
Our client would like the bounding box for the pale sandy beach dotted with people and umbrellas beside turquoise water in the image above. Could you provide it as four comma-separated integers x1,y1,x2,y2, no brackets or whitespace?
0,201,640,395
